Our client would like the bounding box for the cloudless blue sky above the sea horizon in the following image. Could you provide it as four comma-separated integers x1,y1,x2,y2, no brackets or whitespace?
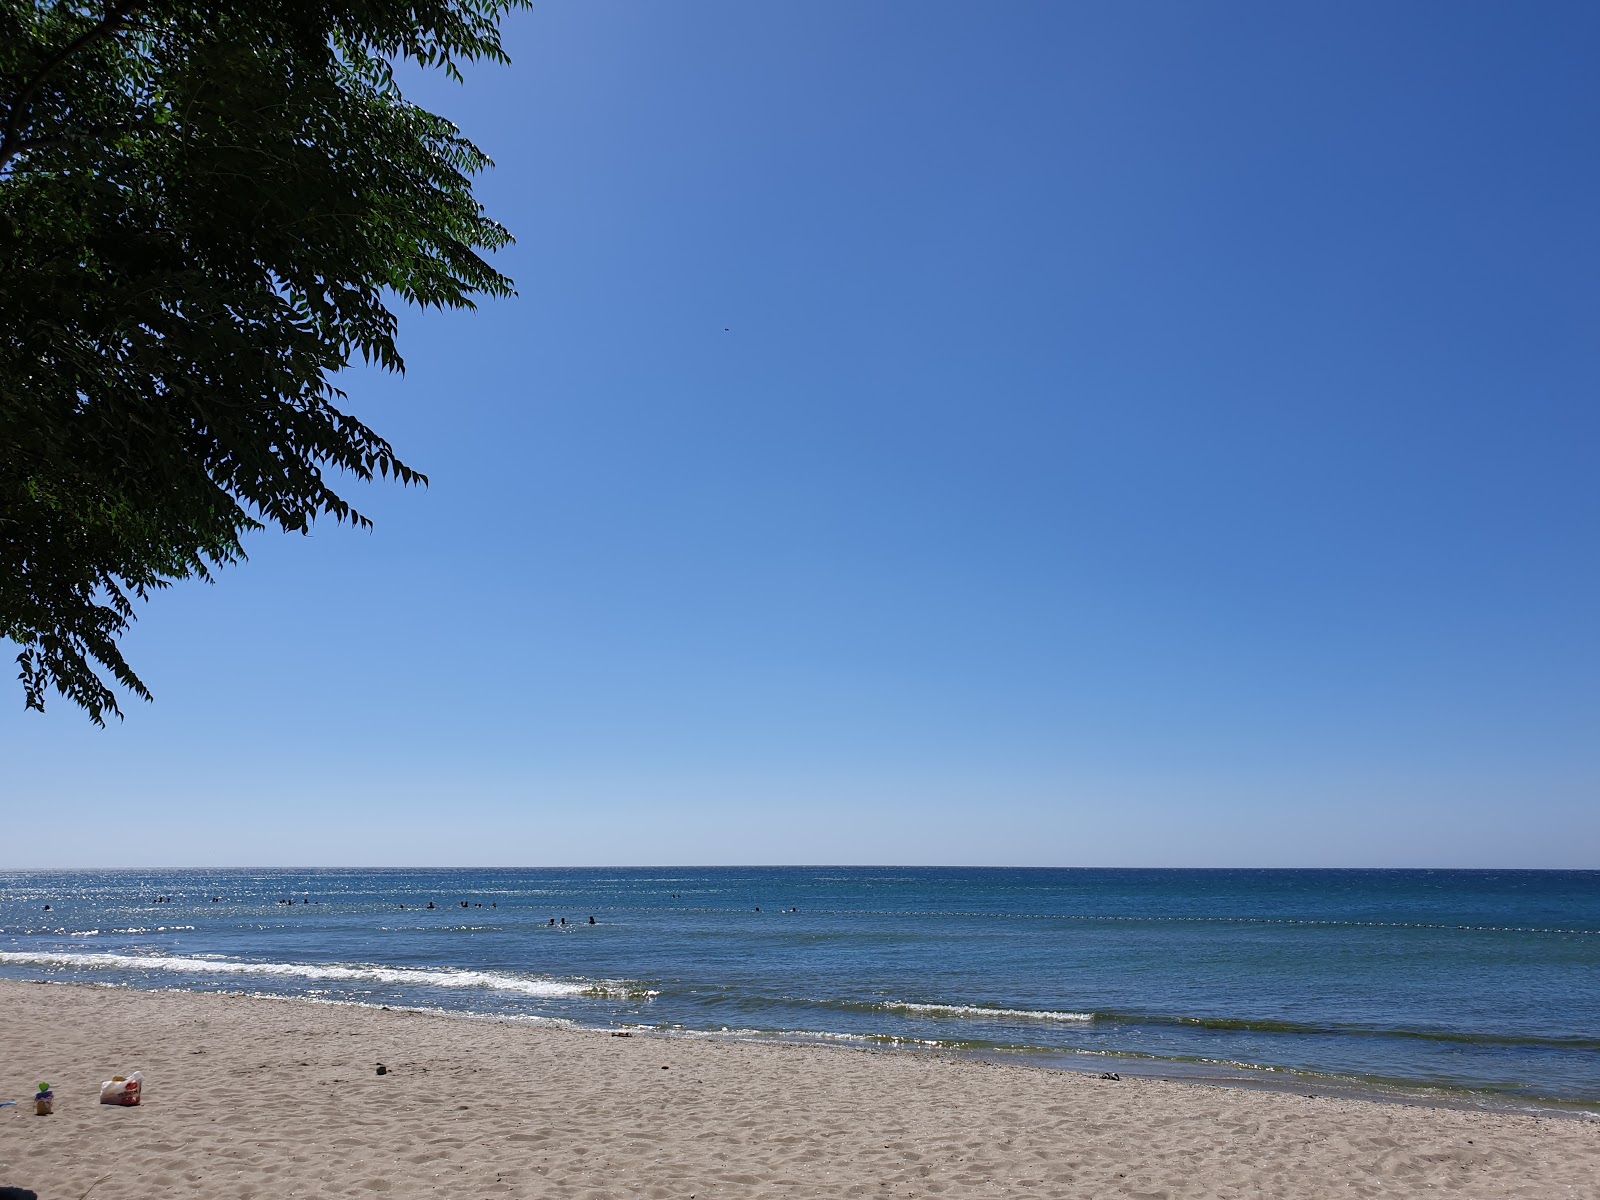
0,0,1600,867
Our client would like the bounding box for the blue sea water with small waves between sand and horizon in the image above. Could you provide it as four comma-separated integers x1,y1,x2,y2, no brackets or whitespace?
0,867,1600,1112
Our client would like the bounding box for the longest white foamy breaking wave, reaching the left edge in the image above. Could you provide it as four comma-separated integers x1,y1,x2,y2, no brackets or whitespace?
0,950,656,1000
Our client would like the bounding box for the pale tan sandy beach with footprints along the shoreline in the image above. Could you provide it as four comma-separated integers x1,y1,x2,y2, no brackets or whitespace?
0,981,1600,1200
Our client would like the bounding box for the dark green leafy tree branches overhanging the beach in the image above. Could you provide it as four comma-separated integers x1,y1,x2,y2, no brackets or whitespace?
0,0,526,725
